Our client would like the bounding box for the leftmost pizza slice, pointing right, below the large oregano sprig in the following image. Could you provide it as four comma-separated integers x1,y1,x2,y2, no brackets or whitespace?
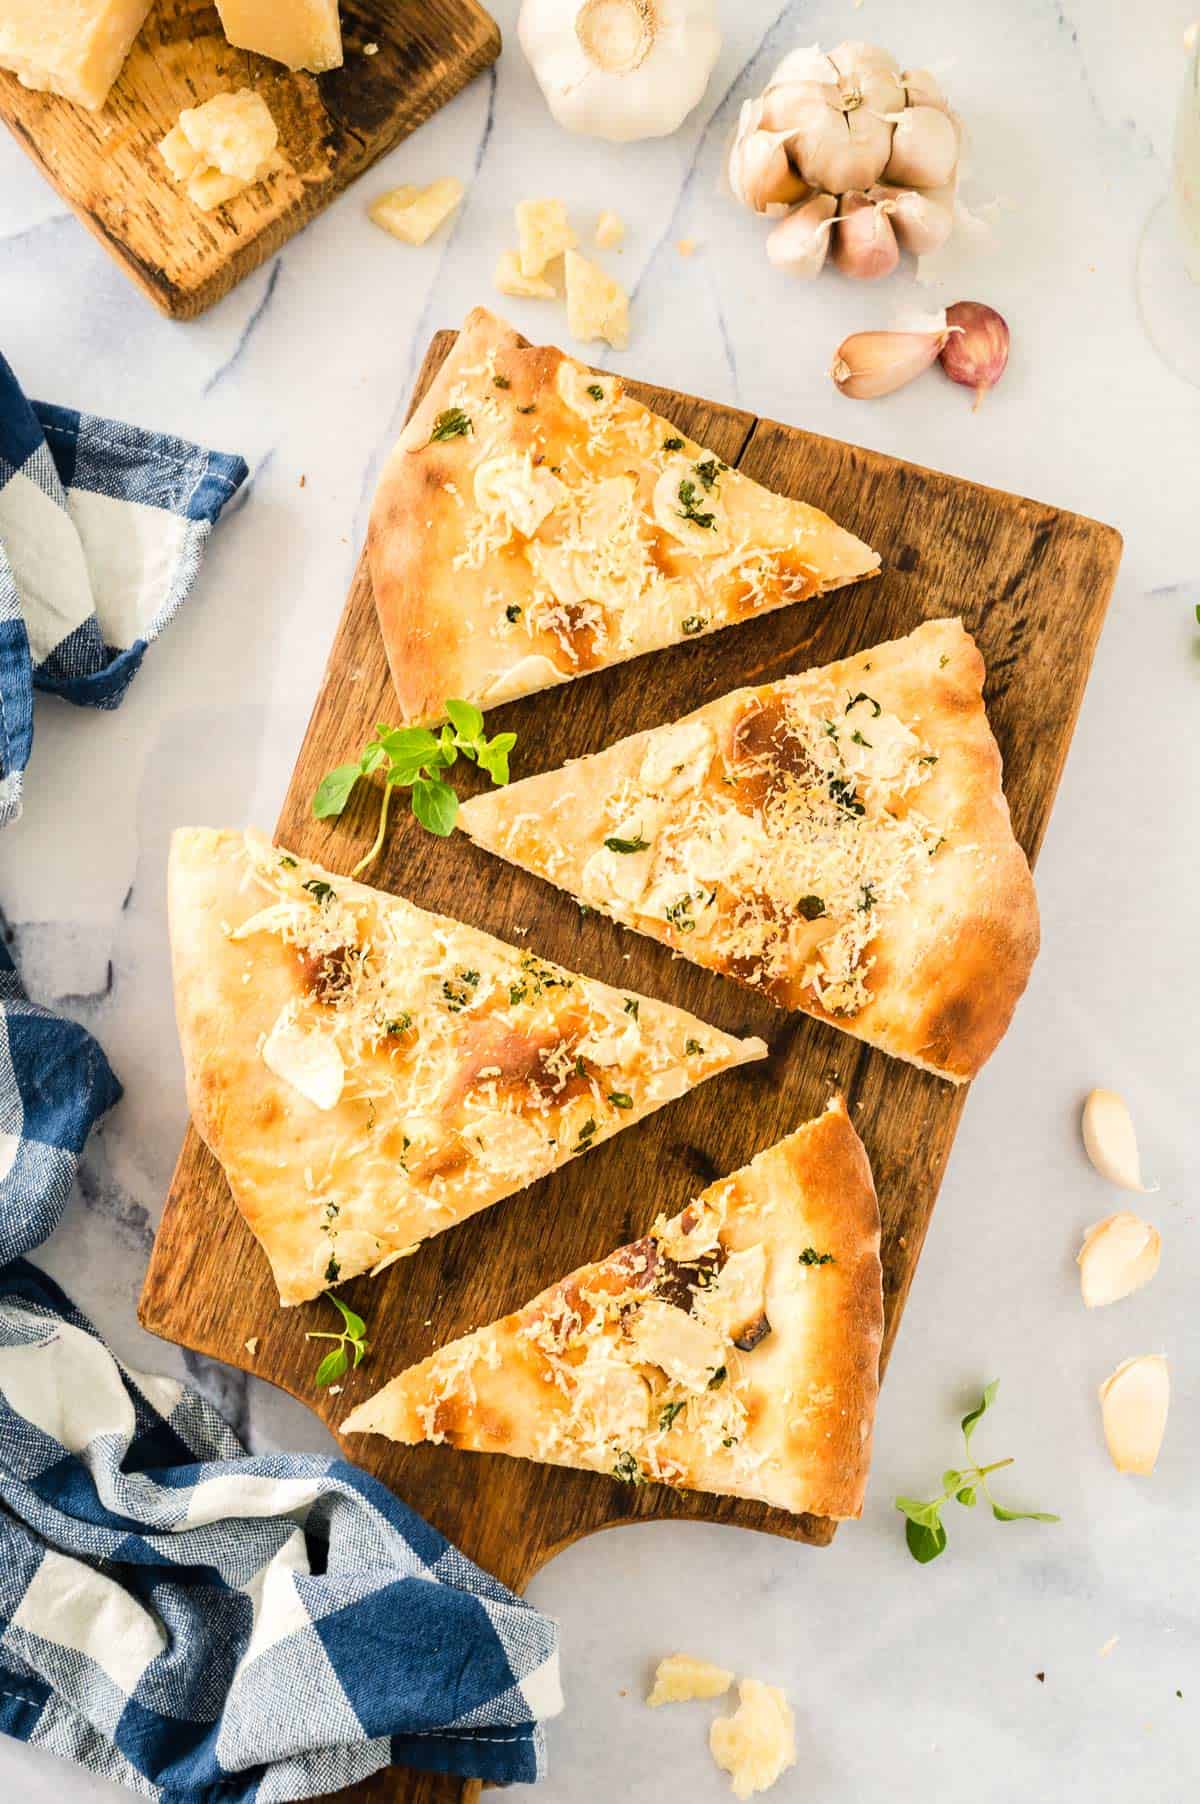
168,828,767,1302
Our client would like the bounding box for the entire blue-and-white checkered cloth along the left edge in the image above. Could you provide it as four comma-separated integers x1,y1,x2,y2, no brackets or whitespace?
0,359,561,1804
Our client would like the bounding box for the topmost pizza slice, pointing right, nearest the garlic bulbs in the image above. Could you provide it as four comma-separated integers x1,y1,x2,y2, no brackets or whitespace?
368,308,879,725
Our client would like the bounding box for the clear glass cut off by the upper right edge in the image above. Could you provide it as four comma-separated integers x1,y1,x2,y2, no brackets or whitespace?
1137,38,1200,388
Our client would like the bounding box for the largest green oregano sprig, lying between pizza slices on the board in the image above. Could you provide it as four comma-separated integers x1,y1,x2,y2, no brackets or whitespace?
312,702,516,877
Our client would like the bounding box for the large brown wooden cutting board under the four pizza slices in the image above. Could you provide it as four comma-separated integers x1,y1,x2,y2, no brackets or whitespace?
141,332,1121,1804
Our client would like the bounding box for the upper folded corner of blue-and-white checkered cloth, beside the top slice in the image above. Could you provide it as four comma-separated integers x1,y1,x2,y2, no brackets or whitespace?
0,357,247,826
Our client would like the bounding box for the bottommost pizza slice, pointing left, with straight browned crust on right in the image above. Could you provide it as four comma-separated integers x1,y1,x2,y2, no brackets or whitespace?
341,1097,882,1517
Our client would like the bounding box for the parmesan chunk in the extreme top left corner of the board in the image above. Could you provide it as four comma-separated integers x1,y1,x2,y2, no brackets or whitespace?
0,0,152,112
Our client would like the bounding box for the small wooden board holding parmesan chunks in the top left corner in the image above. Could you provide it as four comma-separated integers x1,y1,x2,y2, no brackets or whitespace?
0,0,500,319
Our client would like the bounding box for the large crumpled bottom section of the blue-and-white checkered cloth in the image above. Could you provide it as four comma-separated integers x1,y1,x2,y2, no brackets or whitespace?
0,1259,561,1804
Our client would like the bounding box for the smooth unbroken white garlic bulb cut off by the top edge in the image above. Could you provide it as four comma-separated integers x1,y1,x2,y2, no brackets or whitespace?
516,0,720,143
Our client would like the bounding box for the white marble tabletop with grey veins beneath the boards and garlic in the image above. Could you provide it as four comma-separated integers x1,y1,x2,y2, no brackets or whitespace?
0,0,1200,1804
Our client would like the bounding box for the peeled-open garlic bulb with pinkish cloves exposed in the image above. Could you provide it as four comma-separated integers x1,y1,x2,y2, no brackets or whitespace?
729,43,960,280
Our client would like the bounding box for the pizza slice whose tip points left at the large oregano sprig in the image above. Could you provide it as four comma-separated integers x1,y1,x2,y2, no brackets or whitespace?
458,621,1038,1082
